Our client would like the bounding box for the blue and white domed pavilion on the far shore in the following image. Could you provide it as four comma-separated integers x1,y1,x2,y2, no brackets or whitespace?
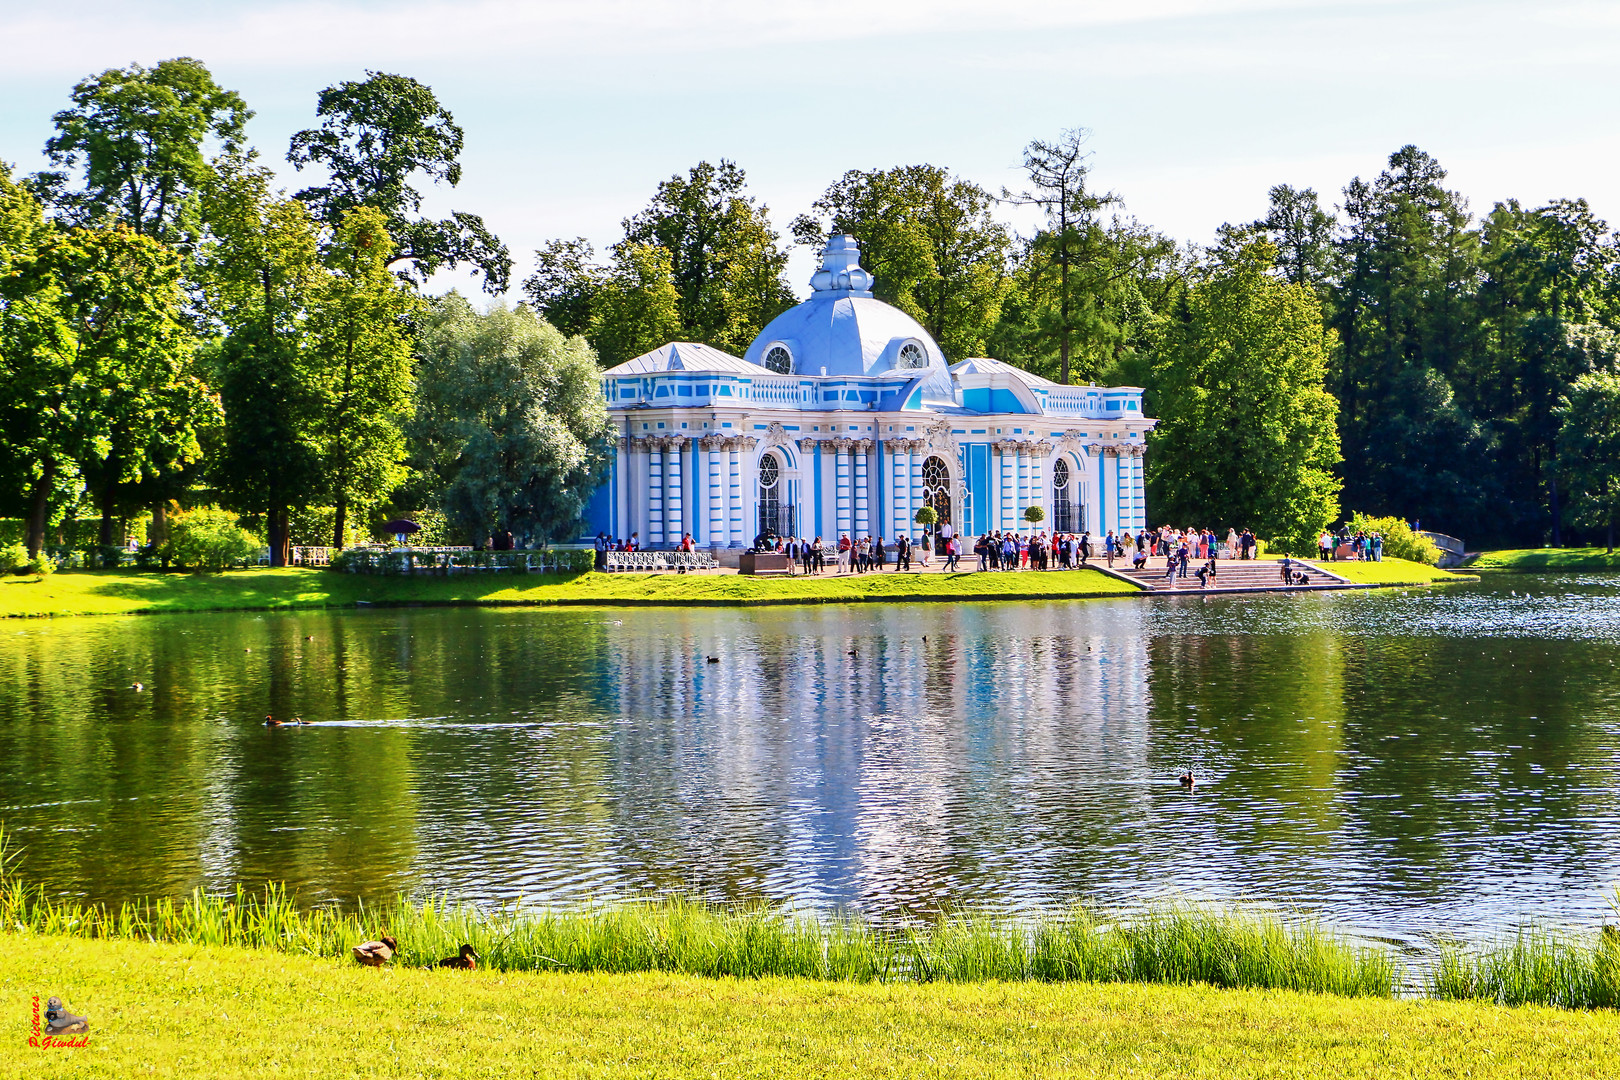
586,236,1155,551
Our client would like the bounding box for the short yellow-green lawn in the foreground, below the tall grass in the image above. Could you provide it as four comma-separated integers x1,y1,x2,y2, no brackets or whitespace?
0,934,1620,1080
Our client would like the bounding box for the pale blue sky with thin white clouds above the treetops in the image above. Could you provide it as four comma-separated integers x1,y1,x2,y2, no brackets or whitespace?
0,0,1620,291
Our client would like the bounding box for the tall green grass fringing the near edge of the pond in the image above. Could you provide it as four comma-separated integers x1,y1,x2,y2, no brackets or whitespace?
0,829,1620,1007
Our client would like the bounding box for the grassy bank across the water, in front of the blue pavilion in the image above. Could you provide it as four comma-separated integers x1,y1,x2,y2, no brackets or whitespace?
0,567,1139,617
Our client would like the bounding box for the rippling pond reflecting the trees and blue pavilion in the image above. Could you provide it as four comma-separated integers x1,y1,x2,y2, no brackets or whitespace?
0,575,1620,942
